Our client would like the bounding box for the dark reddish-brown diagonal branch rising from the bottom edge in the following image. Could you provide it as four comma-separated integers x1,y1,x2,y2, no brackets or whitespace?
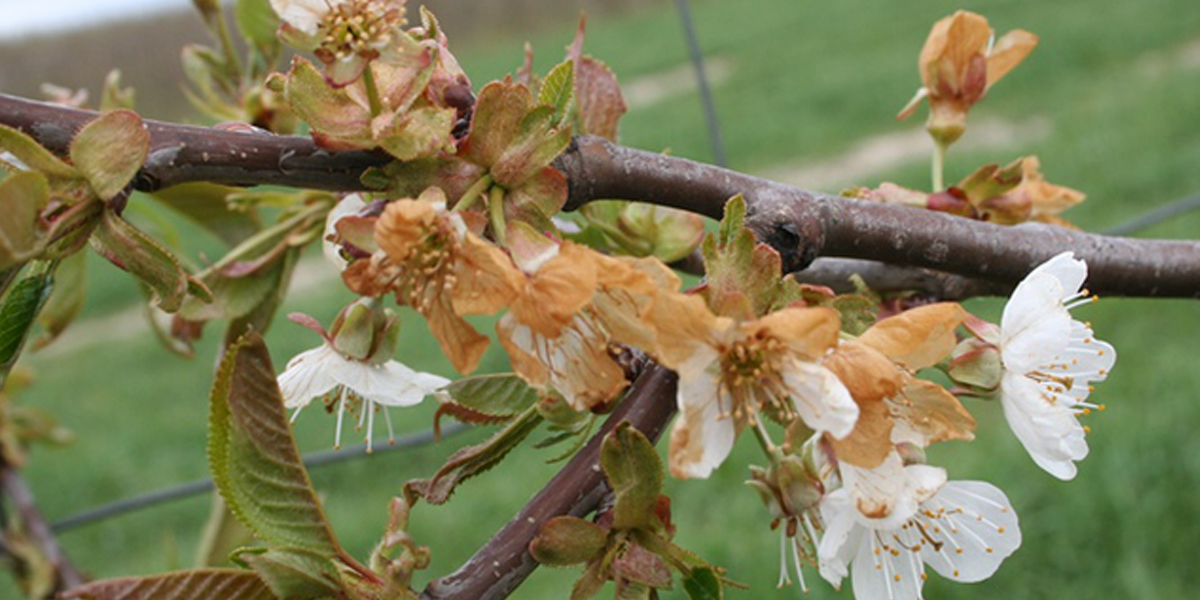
422,365,676,600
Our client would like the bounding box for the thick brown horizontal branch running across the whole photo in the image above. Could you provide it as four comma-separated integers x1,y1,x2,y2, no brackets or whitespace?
0,95,1200,298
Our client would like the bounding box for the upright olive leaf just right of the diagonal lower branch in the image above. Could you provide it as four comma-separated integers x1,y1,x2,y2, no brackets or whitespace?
600,422,662,529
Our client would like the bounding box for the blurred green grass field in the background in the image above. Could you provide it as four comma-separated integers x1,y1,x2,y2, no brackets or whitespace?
0,0,1200,599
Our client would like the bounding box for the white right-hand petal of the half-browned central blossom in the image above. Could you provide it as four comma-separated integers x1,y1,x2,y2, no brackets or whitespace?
780,356,858,439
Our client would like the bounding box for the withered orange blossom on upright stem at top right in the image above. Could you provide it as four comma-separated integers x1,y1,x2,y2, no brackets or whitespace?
898,11,1038,145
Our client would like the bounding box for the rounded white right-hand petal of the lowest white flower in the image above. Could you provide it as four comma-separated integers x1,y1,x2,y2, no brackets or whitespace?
920,481,1021,583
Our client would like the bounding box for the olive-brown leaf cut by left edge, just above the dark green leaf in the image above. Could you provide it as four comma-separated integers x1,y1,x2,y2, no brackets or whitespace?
0,170,49,269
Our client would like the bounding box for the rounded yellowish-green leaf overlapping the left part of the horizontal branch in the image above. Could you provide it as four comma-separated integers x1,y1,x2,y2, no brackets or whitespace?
70,109,150,200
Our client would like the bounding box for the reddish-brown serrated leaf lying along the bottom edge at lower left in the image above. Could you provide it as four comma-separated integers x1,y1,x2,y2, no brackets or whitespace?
60,569,275,600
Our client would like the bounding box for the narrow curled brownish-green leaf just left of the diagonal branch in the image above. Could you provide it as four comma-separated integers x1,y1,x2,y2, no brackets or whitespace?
404,408,541,504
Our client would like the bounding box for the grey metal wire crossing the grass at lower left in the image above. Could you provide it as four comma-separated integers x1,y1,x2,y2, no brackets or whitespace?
50,424,470,533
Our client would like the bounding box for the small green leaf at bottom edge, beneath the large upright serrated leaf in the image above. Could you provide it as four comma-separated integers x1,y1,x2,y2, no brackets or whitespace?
238,548,342,600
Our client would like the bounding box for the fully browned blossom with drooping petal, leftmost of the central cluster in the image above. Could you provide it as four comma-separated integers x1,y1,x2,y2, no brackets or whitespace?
360,187,521,373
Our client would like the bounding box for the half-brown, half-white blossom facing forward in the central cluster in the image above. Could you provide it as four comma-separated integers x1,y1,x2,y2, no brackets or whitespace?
654,294,858,478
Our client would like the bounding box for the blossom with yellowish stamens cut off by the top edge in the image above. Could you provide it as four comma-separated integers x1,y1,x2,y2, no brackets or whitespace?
271,0,406,85
